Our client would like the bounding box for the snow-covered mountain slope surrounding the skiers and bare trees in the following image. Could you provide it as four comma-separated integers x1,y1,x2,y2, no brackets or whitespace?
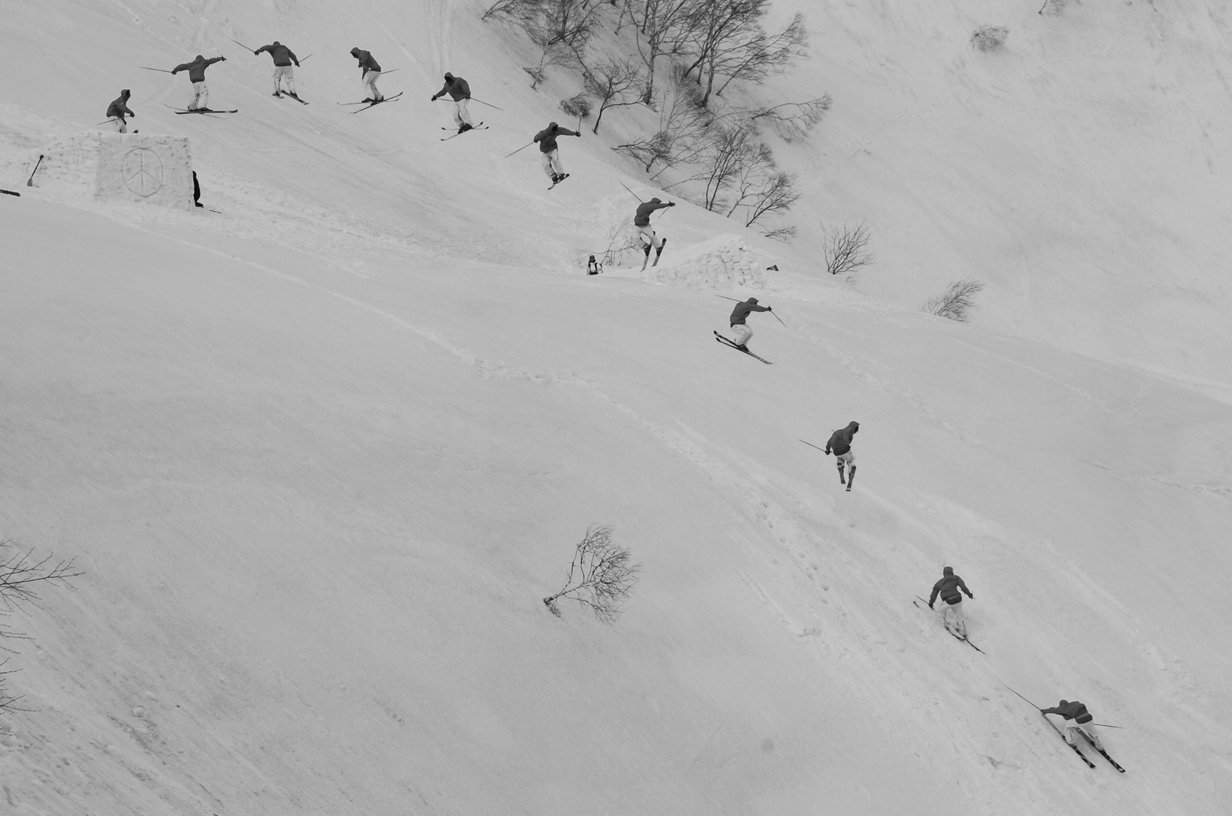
0,0,1232,816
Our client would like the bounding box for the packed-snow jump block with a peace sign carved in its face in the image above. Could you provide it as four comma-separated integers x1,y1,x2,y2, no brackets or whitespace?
34,131,193,210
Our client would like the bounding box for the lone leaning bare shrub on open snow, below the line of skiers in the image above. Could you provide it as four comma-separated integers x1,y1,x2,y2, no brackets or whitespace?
543,526,642,624
